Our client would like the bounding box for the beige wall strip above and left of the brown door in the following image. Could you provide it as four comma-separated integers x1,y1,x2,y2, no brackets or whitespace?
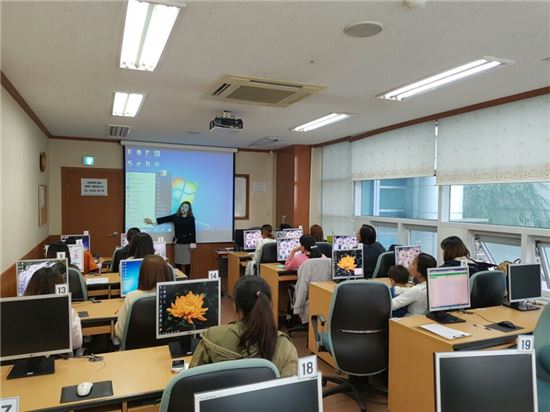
48,139,123,235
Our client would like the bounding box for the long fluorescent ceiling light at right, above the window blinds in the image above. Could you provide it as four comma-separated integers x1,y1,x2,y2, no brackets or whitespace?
378,57,513,100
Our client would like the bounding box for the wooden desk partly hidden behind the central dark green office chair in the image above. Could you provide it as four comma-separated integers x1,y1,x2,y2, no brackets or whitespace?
308,278,391,368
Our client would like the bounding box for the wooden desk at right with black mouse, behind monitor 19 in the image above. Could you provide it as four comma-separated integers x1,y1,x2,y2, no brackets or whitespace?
388,306,542,412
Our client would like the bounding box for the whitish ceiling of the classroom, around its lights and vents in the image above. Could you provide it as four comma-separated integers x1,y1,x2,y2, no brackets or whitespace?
1,1,550,147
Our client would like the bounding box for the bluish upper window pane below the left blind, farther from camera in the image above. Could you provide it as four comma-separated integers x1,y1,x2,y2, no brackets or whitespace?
355,177,439,220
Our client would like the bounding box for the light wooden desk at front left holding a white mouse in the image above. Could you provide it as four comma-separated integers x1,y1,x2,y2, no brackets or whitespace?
1,346,191,411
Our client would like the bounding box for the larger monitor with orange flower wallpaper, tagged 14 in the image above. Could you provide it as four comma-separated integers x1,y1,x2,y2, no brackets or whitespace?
156,278,221,339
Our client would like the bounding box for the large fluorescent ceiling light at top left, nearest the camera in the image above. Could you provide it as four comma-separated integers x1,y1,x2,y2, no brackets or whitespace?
120,0,183,71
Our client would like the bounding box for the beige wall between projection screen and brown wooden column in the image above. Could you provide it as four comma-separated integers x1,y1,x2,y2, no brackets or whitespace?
235,152,276,229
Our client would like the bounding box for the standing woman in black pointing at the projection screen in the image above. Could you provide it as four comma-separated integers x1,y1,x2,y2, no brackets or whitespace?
143,201,197,276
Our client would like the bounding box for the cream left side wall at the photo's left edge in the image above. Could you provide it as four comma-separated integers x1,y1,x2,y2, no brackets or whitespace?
0,88,51,271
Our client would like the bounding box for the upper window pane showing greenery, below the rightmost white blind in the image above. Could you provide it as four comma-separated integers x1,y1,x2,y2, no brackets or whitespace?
450,182,550,228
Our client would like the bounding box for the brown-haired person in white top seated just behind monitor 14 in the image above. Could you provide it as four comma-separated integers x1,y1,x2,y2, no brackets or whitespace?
115,255,173,340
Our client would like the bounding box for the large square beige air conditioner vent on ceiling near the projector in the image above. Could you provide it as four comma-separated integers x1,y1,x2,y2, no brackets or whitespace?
207,74,323,107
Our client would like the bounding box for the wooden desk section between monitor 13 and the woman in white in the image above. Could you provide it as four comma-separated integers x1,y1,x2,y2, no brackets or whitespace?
71,298,124,336
